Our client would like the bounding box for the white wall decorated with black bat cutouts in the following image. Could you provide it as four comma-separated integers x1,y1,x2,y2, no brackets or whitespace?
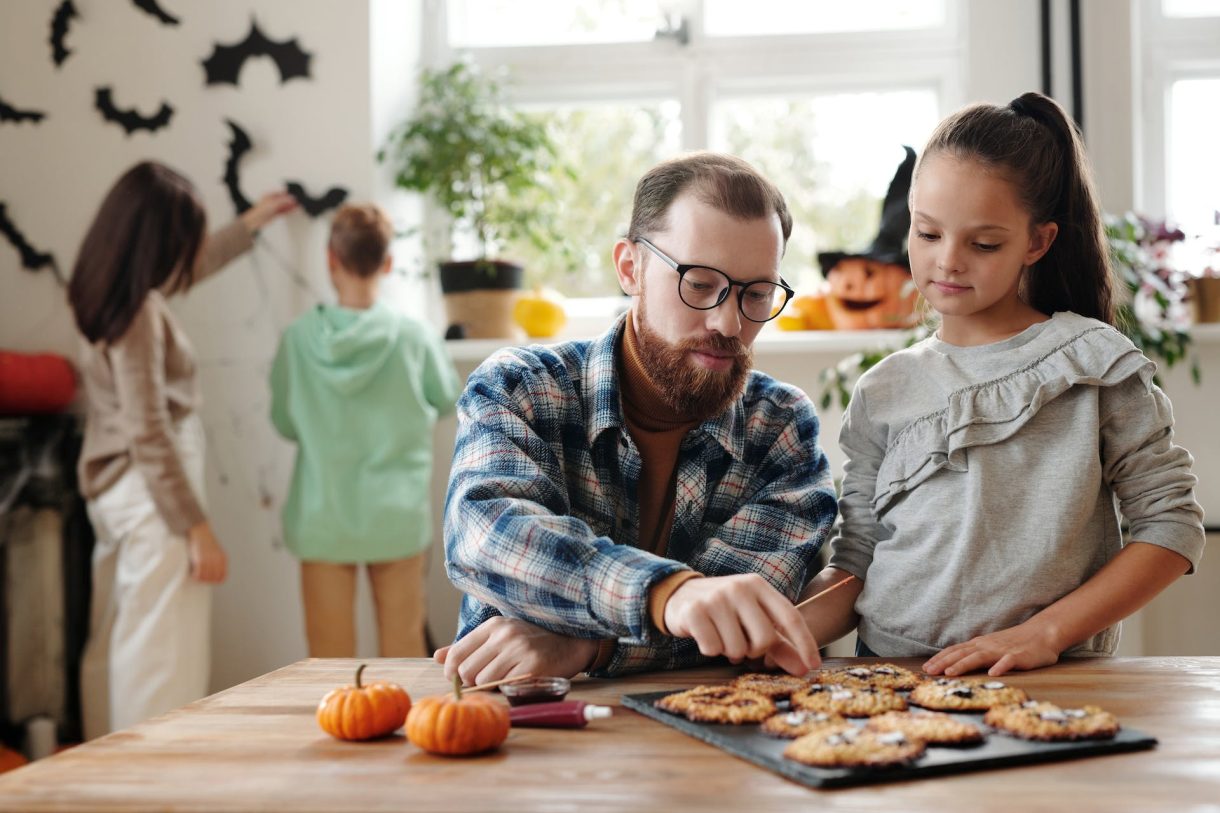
0,0,429,688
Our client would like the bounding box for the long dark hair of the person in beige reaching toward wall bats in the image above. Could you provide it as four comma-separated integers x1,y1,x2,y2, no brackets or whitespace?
68,161,207,343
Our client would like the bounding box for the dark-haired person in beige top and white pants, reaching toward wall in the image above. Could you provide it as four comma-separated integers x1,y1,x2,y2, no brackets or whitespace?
68,162,295,739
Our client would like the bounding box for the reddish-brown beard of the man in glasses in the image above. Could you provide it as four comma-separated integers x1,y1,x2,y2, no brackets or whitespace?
636,297,754,421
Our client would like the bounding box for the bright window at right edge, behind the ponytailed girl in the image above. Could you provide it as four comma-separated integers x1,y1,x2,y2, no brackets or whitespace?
1136,0,1220,236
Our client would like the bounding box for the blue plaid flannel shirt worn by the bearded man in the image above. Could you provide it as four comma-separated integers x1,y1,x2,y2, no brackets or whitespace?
444,319,837,675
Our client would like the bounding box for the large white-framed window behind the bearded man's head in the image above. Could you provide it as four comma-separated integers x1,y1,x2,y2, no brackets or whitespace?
423,0,965,297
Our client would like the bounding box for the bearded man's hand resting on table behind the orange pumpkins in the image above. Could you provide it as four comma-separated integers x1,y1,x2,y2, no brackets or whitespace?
432,615,599,686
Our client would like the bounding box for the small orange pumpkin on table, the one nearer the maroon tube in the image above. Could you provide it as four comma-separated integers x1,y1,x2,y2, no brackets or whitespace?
406,676,511,757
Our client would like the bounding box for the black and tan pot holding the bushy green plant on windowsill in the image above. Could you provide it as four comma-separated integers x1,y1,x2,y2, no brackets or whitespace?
440,260,525,339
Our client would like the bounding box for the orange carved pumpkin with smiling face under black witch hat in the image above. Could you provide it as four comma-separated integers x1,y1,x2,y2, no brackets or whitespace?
826,256,919,331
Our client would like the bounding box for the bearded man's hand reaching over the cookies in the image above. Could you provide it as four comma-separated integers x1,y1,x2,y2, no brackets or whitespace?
665,574,822,675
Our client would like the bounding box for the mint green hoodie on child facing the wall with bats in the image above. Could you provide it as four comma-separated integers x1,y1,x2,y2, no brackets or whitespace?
271,303,461,563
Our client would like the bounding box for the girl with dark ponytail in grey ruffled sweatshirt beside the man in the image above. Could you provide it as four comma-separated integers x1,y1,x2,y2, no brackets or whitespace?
805,93,1204,675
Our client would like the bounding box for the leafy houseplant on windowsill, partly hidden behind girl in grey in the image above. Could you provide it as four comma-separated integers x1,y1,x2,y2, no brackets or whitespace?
820,212,1202,409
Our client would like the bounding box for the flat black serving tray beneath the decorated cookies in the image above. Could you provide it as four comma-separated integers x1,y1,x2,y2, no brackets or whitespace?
622,690,1157,787
